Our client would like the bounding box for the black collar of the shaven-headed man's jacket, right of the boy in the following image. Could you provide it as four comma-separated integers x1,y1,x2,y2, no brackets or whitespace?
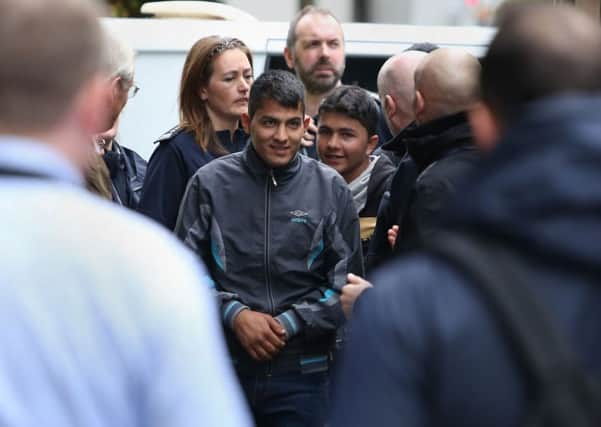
399,112,473,170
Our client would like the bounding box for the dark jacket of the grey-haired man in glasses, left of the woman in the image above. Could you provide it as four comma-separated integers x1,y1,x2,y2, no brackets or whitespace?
102,140,146,209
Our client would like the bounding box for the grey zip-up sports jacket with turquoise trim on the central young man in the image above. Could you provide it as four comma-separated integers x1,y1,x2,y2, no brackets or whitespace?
175,144,363,372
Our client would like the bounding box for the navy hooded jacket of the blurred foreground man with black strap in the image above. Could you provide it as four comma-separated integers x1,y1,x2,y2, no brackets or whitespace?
331,97,601,427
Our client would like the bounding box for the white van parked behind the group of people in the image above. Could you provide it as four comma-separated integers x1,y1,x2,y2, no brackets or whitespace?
103,18,494,159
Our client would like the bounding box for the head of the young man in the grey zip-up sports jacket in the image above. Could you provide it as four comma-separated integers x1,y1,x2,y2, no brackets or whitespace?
242,70,310,168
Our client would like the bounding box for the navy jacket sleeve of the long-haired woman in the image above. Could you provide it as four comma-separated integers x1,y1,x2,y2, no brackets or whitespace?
138,142,188,230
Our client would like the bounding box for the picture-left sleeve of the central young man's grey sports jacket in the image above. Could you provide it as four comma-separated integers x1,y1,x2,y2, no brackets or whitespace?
175,174,248,329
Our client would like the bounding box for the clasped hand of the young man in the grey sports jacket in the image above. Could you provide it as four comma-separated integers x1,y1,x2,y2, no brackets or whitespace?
234,310,286,361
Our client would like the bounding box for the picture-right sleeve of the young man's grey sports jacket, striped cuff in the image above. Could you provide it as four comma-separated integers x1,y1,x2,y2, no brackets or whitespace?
276,185,363,337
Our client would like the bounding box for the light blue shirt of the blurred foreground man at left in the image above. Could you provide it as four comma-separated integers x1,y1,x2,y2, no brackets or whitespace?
0,137,250,427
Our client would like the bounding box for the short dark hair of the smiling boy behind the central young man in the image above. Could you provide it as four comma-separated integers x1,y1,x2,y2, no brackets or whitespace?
319,86,379,136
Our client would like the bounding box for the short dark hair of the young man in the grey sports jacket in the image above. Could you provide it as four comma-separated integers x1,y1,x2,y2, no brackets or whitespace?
248,70,305,119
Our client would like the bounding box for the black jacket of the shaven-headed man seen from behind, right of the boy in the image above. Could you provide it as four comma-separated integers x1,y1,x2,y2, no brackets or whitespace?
367,113,480,271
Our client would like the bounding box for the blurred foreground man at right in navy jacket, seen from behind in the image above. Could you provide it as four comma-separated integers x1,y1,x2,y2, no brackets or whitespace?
331,6,601,427
